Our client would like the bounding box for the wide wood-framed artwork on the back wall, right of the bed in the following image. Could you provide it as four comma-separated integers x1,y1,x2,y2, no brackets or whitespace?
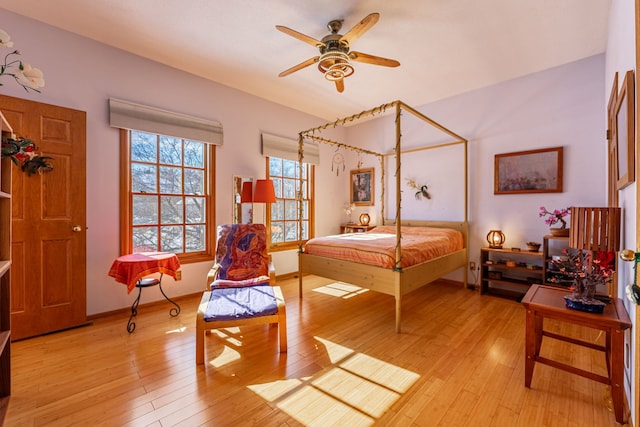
493,147,563,194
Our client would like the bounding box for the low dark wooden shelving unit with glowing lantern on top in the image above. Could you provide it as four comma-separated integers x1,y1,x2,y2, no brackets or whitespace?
480,248,543,299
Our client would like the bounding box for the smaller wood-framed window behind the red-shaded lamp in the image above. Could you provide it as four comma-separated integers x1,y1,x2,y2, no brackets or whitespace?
267,157,313,250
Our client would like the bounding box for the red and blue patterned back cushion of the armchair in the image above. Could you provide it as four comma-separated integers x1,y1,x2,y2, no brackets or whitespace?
216,224,269,281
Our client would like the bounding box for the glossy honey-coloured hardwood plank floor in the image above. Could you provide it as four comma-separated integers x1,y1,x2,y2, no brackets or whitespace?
5,277,628,427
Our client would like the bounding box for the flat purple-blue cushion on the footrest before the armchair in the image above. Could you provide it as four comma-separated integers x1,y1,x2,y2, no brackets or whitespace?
204,285,278,322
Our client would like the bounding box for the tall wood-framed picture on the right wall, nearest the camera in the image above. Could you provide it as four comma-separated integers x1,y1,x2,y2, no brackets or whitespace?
613,70,636,190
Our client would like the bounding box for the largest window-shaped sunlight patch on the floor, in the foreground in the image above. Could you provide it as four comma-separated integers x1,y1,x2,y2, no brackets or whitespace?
248,337,420,426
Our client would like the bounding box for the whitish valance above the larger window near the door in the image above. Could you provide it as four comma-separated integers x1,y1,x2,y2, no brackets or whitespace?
109,98,222,145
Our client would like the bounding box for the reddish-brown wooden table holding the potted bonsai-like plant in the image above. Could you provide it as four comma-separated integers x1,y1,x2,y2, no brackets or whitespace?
522,285,631,424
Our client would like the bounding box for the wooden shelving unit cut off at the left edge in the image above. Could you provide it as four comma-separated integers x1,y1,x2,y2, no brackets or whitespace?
0,113,14,423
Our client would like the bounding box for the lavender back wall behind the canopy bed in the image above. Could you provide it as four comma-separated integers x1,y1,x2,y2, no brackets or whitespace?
348,55,606,277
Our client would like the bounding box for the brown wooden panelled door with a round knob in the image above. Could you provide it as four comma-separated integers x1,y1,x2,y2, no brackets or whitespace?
0,96,86,340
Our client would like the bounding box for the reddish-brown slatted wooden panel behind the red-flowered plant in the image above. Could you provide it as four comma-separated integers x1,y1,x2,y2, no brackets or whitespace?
569,207,621,252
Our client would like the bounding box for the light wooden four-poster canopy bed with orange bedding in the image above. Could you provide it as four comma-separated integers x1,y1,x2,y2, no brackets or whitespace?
298,101,469,333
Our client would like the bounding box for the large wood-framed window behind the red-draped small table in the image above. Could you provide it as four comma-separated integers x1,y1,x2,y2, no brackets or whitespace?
121,130,214,262
